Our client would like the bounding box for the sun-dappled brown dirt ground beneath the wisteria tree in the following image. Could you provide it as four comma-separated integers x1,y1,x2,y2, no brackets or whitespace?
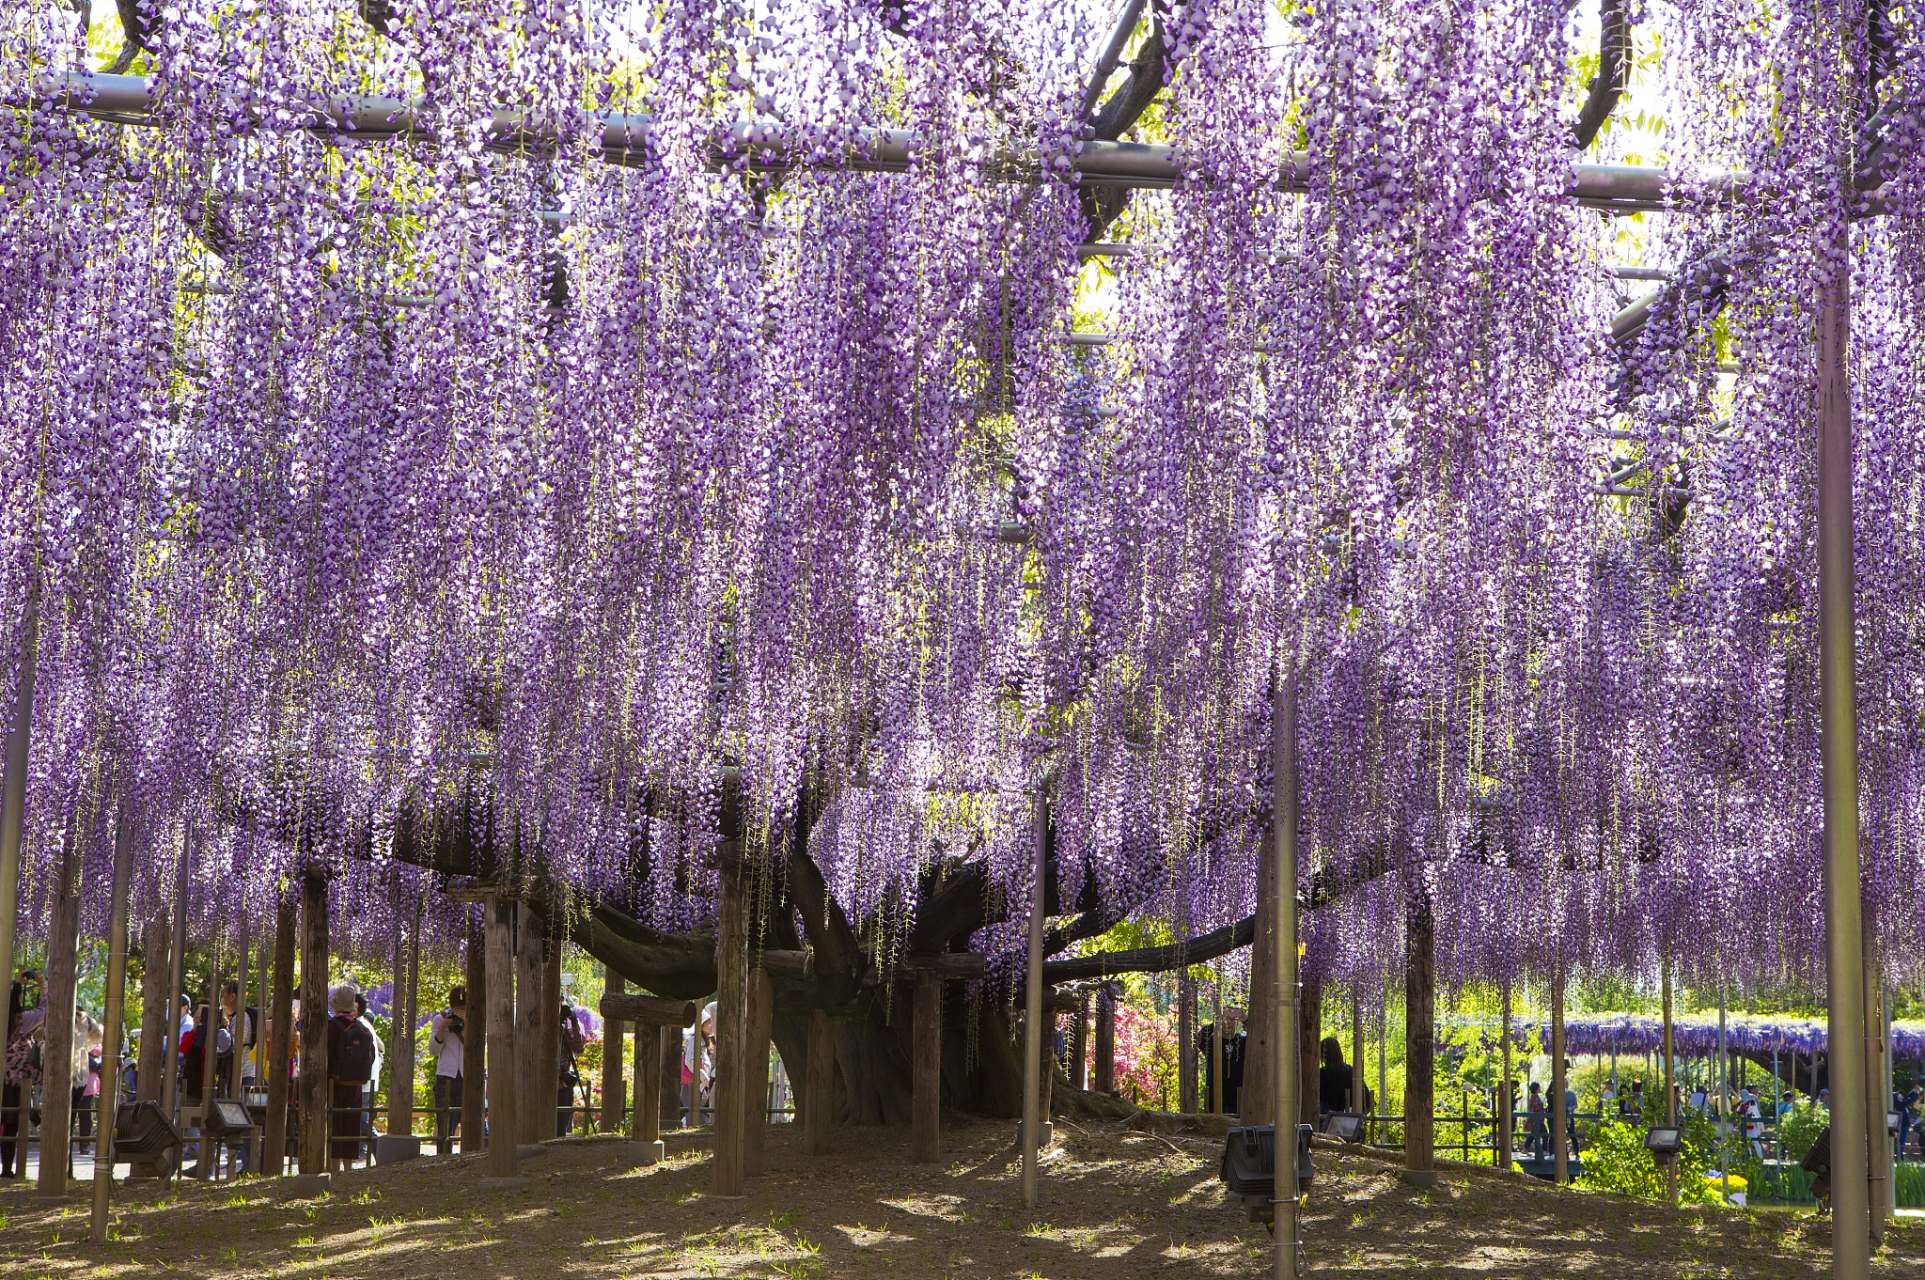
0,1120,1925,1280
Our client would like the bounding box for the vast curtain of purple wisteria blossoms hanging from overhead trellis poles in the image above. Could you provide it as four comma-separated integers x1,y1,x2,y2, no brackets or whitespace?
0,0,1925,991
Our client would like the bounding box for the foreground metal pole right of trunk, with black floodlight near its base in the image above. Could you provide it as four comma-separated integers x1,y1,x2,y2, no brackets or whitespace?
1251,660,1301,1280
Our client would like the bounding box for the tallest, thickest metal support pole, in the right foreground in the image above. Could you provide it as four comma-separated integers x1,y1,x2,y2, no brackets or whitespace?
1815,197,1871,1280
